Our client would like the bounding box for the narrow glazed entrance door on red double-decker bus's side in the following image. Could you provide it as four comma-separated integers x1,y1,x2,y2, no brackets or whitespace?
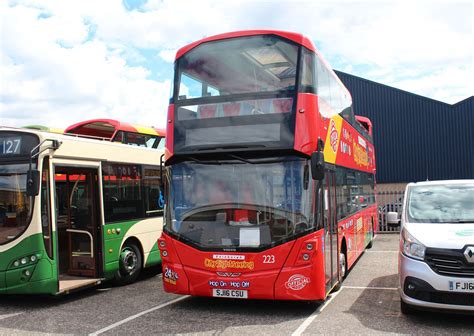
323,170,339,292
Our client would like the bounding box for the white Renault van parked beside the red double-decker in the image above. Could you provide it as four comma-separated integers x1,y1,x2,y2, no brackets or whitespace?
390,180,474,314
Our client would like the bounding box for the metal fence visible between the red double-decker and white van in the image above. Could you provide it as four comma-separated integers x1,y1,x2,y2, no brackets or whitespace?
377,190,404,232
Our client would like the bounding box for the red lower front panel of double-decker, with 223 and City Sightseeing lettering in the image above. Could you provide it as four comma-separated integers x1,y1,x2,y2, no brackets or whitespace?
159,230,326,300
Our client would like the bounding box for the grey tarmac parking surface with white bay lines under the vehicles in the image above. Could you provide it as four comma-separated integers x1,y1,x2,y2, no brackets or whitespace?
0,234,474,336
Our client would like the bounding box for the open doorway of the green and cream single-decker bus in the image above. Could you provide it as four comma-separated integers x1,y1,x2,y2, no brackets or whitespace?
53,166,102,292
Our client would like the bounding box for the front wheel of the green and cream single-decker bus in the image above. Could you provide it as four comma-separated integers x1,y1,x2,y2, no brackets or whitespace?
115,242,143,285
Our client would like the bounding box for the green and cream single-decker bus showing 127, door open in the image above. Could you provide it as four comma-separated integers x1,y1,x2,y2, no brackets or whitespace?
0,127,164,295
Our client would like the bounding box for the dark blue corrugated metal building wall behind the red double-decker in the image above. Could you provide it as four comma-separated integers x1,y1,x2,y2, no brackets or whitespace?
336,71,474,183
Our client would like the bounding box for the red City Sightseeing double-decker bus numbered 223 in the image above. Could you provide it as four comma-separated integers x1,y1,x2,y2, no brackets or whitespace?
158,30,377,300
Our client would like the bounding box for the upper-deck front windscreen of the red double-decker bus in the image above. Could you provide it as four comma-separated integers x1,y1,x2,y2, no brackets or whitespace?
177,35,298,101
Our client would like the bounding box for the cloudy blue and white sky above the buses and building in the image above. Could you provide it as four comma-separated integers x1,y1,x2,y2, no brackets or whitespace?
0,0,474,127
